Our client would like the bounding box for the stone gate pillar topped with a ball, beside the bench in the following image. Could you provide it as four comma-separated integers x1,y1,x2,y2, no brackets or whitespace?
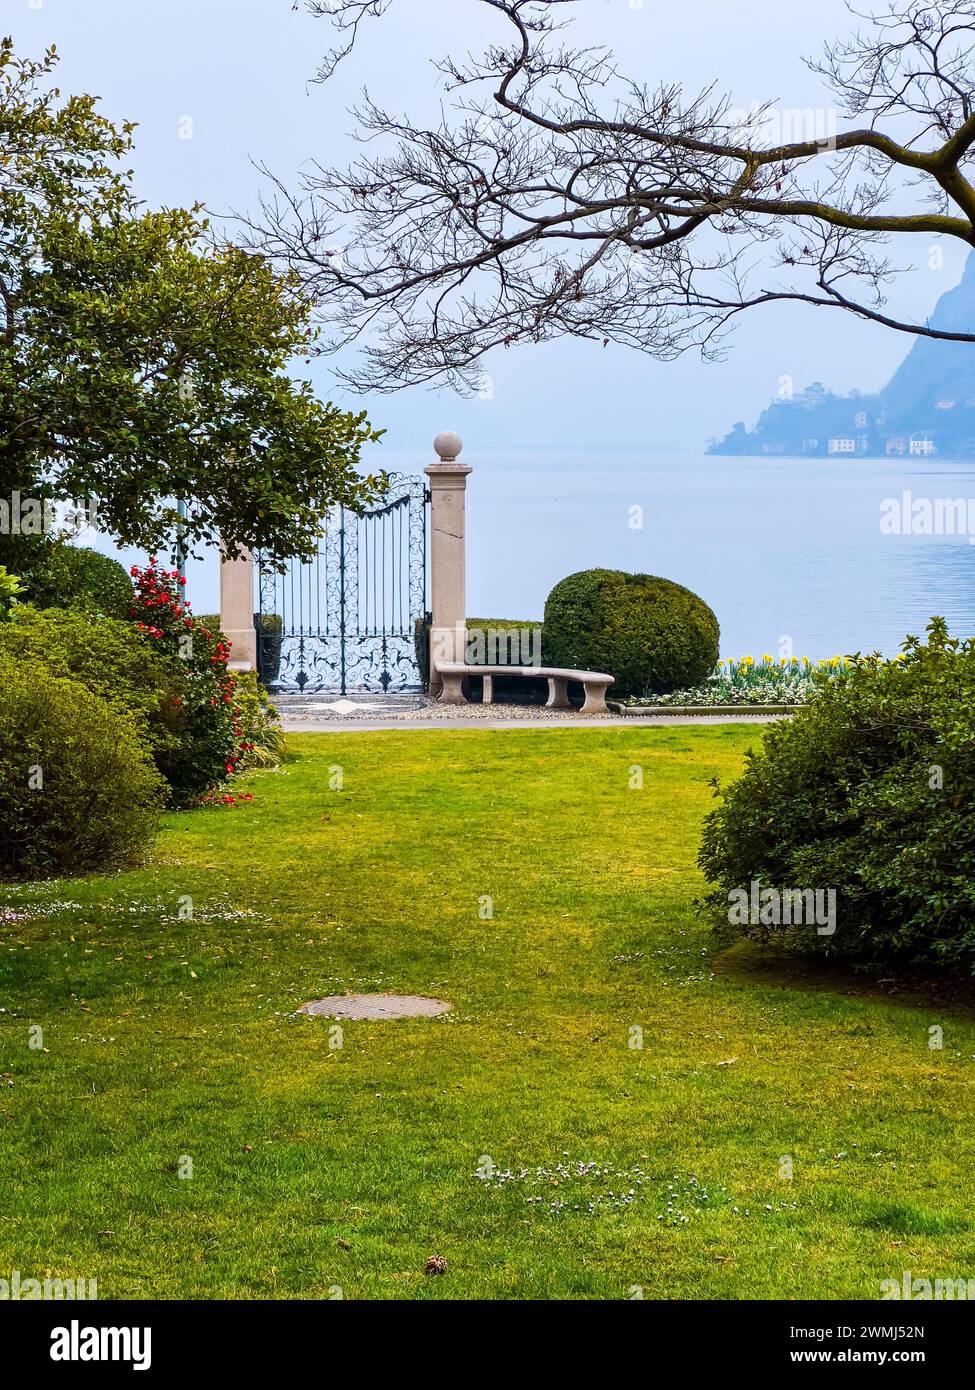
423,430,472,695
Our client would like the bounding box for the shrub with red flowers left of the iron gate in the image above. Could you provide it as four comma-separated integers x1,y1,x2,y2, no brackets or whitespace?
129,559,248,805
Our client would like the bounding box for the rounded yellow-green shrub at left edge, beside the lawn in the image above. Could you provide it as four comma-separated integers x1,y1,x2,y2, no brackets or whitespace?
0,659,166,877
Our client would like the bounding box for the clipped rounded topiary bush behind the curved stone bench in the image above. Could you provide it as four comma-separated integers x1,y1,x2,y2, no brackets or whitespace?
542,570,719,696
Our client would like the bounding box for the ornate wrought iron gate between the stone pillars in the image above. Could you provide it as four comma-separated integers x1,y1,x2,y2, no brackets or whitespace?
255,474,430,695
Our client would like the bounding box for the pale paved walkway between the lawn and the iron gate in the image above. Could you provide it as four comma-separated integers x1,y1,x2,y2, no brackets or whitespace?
274,692,777,734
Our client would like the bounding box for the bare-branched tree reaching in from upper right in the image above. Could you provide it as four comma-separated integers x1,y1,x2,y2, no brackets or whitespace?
249,0,975,391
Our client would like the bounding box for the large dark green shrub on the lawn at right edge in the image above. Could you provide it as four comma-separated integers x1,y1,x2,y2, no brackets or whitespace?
700,619,975,976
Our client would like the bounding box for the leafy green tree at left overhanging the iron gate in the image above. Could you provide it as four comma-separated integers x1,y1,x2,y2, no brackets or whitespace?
0,39,380,569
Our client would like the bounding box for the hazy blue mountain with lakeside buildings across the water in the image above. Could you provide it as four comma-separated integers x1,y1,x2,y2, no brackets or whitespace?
708,254,975,457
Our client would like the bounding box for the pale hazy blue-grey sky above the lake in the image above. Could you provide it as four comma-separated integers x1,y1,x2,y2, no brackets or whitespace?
11,0,961,456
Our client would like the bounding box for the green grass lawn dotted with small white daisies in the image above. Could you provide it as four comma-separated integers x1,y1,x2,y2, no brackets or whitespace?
0,726,975,1298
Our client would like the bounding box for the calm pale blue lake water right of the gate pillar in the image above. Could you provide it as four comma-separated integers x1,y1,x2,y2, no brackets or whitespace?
453,450,975,659
